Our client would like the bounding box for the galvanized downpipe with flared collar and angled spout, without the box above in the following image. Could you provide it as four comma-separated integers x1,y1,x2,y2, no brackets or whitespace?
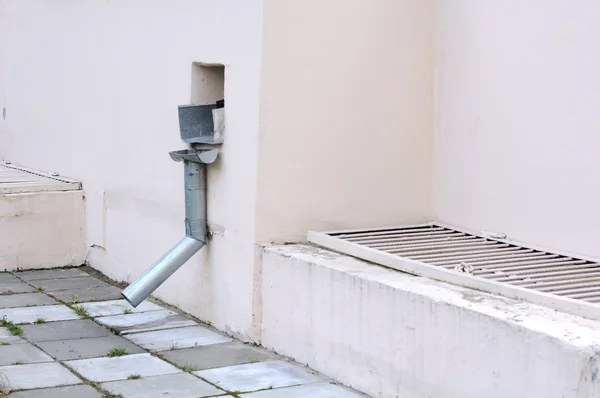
121,149,218,307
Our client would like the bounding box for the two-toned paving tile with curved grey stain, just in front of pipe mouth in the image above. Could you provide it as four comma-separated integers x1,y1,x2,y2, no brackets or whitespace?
96,310,196,334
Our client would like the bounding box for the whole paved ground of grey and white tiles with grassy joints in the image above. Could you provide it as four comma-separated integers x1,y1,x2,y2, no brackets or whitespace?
0,267,365,398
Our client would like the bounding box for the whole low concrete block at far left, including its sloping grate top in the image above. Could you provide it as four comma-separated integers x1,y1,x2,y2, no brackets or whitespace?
0,163,85,270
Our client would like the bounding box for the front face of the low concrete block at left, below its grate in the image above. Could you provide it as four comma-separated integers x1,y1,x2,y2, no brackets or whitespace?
0,190,85,271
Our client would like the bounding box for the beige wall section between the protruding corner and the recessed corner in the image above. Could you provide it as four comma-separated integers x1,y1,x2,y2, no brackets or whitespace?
256,0,434,242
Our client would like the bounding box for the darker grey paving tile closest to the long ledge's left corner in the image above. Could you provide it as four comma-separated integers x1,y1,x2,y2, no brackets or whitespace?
159,340,277,370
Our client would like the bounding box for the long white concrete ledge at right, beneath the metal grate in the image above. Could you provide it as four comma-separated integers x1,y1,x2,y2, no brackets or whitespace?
262,245,600,398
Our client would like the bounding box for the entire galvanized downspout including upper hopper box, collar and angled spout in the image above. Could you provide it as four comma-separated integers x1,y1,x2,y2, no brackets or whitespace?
121,102,222,307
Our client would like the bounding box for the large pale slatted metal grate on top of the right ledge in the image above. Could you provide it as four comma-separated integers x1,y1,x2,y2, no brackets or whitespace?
308,223,600,320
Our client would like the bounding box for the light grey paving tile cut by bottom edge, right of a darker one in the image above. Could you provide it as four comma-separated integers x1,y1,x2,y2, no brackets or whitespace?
102,373,225,398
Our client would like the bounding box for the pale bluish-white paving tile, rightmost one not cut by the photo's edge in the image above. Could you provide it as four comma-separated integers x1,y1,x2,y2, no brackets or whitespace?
193,361,324,392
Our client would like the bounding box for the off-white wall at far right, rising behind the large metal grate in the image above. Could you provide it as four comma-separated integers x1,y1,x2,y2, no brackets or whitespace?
433,0,600,257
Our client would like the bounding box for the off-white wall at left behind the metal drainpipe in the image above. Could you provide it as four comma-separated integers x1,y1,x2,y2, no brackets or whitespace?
0,0,262,339
